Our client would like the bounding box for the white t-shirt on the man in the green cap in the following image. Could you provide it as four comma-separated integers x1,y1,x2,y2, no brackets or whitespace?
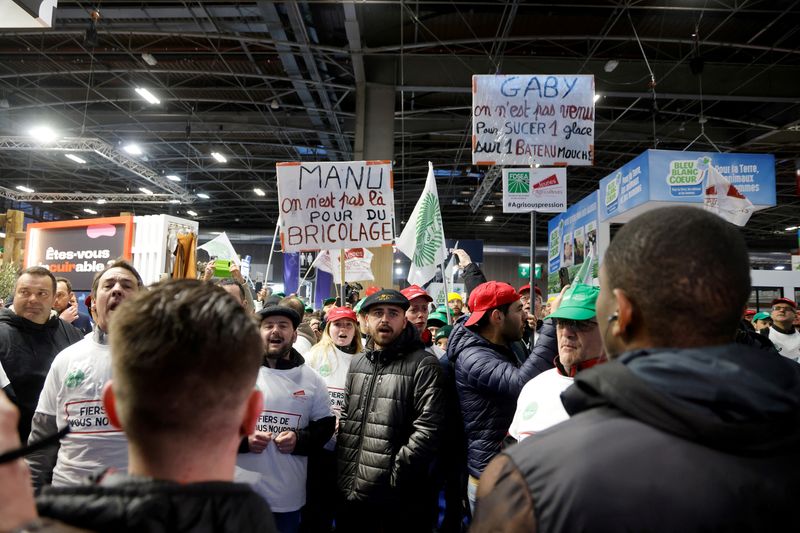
508,368,573,441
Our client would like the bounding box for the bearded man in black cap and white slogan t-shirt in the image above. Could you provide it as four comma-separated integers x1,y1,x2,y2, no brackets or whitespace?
235,305,336,533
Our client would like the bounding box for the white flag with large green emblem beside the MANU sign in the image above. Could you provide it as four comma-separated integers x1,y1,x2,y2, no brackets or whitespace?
396,162,447,286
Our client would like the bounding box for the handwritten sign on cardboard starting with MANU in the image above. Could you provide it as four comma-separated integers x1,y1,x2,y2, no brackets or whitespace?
277,161,394,252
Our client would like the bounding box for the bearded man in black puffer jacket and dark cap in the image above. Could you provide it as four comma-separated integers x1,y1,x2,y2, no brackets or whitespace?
336,290,446,533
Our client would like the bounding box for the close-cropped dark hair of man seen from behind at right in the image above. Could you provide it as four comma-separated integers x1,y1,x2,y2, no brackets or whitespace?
603,206,750,348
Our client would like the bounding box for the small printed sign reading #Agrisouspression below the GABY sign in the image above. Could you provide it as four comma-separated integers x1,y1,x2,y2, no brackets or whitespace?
503,168,567,213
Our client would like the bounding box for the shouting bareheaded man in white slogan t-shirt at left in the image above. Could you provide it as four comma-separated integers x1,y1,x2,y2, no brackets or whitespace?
28,260,143,491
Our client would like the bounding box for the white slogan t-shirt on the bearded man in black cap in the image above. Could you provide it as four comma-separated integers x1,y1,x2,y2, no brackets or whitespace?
235,364,333,513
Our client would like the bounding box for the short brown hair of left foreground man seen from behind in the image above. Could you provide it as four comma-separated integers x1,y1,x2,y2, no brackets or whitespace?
109,279,264,448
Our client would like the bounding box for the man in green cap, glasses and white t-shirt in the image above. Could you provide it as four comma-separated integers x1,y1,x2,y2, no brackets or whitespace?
508,283,605,441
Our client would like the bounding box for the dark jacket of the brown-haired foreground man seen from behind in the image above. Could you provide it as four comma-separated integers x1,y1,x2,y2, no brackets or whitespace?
36,474,278,533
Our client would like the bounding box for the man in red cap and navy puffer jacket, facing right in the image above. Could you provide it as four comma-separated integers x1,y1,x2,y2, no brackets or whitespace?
447,281,557,506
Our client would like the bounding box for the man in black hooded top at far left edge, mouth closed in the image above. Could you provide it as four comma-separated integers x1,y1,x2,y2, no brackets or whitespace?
0,267,83,442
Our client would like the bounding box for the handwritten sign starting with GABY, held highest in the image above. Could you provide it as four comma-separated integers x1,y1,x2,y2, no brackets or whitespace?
472,75,594,166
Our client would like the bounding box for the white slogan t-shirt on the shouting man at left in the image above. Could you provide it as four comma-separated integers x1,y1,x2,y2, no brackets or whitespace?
36,336,128,487
